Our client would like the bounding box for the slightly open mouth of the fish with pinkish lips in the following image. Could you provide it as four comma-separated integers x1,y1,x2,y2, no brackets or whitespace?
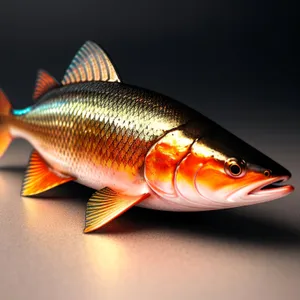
248,176,294,198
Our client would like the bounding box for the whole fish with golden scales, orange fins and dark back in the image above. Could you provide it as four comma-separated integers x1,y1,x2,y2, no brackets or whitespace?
0,42,293,232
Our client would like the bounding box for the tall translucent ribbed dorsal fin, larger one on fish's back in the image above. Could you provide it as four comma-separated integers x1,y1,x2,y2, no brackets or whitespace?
62,41,121,85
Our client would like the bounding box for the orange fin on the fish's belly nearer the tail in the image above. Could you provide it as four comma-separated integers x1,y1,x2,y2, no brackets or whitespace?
21,150,75,196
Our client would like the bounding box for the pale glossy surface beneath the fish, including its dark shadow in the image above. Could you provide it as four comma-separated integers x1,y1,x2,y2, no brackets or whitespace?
0,141,300,300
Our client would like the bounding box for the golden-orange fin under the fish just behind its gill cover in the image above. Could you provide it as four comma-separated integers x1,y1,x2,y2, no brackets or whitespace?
84,187,150,233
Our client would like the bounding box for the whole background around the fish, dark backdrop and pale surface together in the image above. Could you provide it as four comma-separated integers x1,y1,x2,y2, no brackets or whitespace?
0,0,300,300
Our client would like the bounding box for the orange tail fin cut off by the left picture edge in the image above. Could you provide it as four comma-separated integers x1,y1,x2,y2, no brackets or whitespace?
0,89,12,157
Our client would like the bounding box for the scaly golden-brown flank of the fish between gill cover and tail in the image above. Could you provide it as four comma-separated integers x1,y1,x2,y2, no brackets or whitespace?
12,82,195,191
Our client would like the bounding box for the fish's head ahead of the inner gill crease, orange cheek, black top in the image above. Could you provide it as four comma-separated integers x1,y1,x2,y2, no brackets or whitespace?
177,127,294,208
